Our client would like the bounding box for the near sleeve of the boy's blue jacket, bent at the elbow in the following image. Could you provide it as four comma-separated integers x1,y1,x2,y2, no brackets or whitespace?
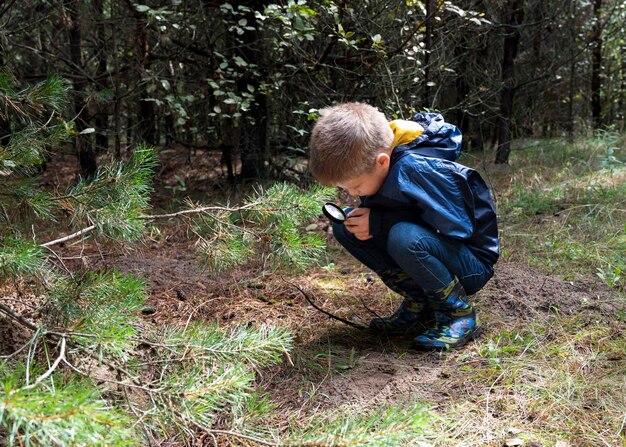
370,161,475,239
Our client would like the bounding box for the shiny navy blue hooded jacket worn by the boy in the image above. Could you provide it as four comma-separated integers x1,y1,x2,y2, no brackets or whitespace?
361,113,499,266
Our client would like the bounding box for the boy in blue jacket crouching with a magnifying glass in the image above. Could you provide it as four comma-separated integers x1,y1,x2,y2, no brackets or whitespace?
309,103,499,350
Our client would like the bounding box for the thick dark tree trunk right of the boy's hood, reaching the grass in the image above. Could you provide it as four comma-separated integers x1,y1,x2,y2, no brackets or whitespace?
495,0,524,164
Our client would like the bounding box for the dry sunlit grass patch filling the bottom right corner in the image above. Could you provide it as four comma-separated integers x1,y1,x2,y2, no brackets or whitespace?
440,316,626,447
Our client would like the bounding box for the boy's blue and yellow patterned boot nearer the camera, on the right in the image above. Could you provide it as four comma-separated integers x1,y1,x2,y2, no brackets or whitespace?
414,278,481,350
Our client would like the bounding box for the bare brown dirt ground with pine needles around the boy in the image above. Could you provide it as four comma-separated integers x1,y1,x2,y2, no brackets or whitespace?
0,148,617,440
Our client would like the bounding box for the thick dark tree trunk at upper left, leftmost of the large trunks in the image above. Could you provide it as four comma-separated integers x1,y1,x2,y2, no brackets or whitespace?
63,0,97,178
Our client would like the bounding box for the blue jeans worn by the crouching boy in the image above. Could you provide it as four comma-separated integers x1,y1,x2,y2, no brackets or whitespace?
333,214,493,298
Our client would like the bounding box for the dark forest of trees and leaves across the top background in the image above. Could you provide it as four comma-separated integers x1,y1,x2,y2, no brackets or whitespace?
0,0,626,181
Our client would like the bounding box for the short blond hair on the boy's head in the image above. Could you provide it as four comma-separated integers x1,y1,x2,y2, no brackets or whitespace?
309,102,393,185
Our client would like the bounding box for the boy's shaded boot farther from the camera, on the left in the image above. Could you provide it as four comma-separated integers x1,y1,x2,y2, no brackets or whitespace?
370,297,434,335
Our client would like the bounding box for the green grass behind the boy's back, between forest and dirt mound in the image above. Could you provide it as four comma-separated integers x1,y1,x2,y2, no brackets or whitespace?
486,134,626,287
